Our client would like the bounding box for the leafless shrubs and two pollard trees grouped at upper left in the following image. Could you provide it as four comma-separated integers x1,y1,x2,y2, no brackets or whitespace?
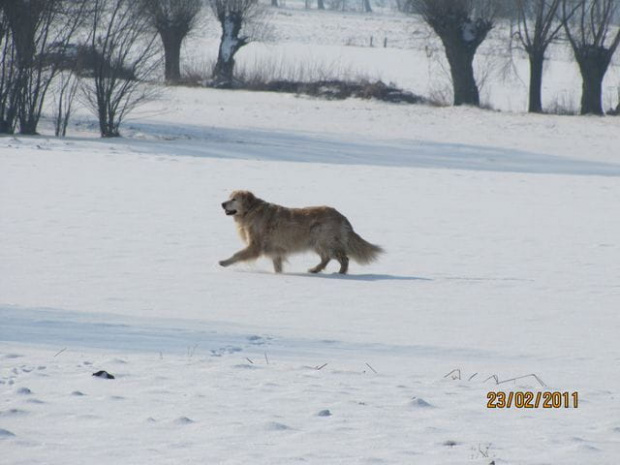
0,0,258,137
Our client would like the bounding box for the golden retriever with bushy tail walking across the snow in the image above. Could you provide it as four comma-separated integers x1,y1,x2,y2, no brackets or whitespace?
219,191,383,274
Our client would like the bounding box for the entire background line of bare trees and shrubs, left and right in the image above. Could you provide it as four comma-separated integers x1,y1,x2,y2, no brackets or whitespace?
0,0,620,137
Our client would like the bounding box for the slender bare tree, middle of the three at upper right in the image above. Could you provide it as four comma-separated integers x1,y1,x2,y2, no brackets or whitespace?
514,0,562,113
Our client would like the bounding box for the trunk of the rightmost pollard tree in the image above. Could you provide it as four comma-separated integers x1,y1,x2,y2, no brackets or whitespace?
575,47,611,115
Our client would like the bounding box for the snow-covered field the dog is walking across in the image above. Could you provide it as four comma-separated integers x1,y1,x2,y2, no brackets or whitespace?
0,3,620,465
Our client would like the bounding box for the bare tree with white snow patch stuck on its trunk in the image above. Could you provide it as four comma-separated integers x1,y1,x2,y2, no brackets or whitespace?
207,0,260,88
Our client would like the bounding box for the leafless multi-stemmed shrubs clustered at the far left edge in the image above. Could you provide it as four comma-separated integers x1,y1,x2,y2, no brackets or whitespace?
0,0,156,136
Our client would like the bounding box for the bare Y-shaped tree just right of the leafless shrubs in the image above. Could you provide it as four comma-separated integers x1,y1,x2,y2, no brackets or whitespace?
142,0,202,83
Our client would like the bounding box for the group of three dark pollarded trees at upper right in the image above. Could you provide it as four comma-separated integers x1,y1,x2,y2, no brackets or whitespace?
409,0,620,115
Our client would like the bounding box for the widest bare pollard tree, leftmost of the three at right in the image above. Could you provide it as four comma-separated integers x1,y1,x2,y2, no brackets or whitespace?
407,0,502,106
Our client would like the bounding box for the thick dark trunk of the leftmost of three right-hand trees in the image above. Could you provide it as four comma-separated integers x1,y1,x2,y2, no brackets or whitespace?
444,42,480,106
